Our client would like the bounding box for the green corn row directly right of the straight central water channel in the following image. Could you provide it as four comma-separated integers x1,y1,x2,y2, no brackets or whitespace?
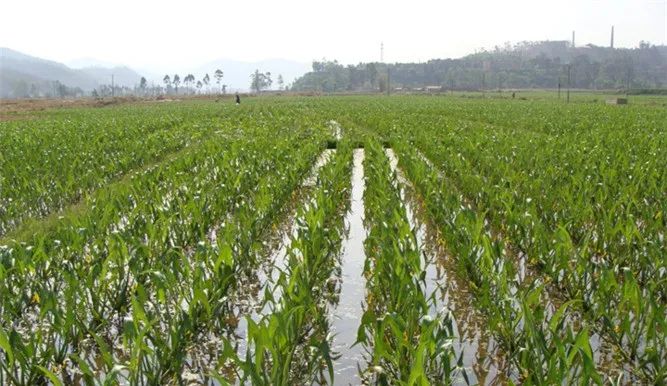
358,140,465,385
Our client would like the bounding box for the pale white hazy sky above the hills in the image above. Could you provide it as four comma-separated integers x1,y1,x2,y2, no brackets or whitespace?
0,0,667,70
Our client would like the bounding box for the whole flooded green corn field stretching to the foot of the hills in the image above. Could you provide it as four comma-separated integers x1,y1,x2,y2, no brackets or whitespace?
0,96,667,385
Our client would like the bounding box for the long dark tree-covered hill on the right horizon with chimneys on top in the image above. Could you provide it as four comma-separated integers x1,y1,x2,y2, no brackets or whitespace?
293,41,667,92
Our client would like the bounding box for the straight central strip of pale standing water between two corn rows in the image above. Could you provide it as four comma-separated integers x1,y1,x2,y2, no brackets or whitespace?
332,149,367,385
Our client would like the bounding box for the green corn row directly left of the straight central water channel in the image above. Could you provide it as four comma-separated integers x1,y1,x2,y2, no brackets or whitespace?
237,139,352,385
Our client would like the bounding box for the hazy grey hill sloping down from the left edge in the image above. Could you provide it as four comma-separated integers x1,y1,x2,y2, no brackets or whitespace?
0,47,141,98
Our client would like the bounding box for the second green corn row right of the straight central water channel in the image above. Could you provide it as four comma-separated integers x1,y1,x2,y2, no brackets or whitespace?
399,145,602,384
